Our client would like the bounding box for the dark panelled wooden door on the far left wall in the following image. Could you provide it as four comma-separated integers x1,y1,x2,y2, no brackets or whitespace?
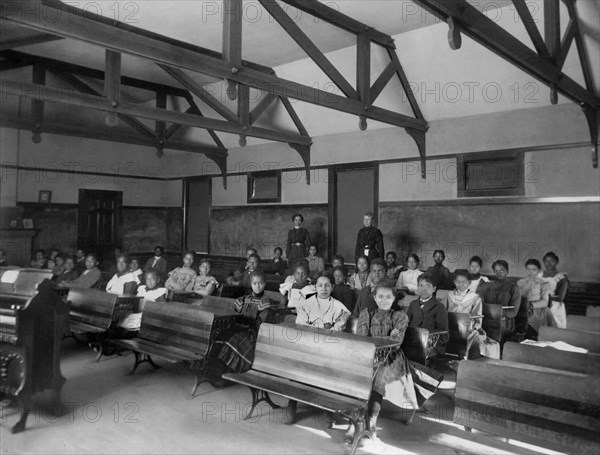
77,190,123,257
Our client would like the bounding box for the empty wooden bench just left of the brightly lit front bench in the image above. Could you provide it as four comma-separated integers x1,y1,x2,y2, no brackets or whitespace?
110,302,238,397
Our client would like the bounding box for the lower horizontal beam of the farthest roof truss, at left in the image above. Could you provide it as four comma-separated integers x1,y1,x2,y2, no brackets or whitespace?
0,115,227,158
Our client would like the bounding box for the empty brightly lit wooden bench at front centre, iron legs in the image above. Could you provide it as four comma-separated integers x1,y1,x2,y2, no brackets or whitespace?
223,323,385,454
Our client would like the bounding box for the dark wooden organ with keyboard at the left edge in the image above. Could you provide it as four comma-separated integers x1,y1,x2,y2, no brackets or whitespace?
0,267,69,433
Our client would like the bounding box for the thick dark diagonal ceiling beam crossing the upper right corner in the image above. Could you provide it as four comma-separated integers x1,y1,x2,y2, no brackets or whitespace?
414,0,600,109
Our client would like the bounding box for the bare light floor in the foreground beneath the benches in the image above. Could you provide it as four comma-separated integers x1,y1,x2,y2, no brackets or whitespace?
0,339,568,455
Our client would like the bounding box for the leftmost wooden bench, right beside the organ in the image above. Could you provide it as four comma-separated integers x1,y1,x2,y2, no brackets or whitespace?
67,288,140,362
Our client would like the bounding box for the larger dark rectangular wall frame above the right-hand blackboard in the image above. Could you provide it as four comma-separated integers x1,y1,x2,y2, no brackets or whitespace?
456,151,525,197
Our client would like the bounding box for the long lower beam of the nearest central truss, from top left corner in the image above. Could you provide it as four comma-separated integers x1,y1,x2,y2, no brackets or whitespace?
0,0,427,132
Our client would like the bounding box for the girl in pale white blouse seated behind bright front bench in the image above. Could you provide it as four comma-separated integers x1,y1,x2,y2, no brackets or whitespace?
296,274,350,332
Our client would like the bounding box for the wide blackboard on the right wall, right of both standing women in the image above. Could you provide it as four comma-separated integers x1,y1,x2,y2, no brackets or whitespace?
379,202,600,282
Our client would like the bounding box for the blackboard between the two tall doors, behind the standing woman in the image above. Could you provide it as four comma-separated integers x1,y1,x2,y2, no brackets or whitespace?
210,205,328,259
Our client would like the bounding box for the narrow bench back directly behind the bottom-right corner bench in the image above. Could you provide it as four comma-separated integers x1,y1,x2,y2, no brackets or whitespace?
502,341,600,376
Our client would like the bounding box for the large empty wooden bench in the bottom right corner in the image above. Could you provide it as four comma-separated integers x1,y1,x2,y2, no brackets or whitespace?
454,360,600,454
